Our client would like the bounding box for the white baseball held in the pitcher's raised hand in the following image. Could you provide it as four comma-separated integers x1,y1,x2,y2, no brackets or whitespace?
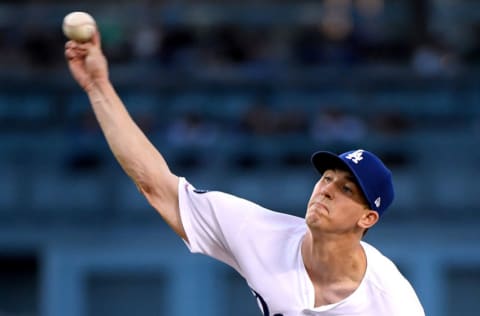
62,11,96,42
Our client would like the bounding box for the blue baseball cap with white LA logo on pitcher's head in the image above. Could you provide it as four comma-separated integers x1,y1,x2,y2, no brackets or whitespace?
312,149,395,215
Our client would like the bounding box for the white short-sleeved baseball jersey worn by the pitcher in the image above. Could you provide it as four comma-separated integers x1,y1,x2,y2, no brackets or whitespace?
179,178,425,316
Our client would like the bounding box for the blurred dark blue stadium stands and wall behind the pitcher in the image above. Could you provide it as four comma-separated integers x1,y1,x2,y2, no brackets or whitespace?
0,0,480,316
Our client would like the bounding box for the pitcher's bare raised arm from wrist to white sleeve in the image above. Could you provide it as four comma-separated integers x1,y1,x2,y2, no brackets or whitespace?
87,80,187,240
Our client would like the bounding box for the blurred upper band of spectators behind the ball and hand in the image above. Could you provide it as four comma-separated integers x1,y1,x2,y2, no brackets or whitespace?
0,0,480,75
